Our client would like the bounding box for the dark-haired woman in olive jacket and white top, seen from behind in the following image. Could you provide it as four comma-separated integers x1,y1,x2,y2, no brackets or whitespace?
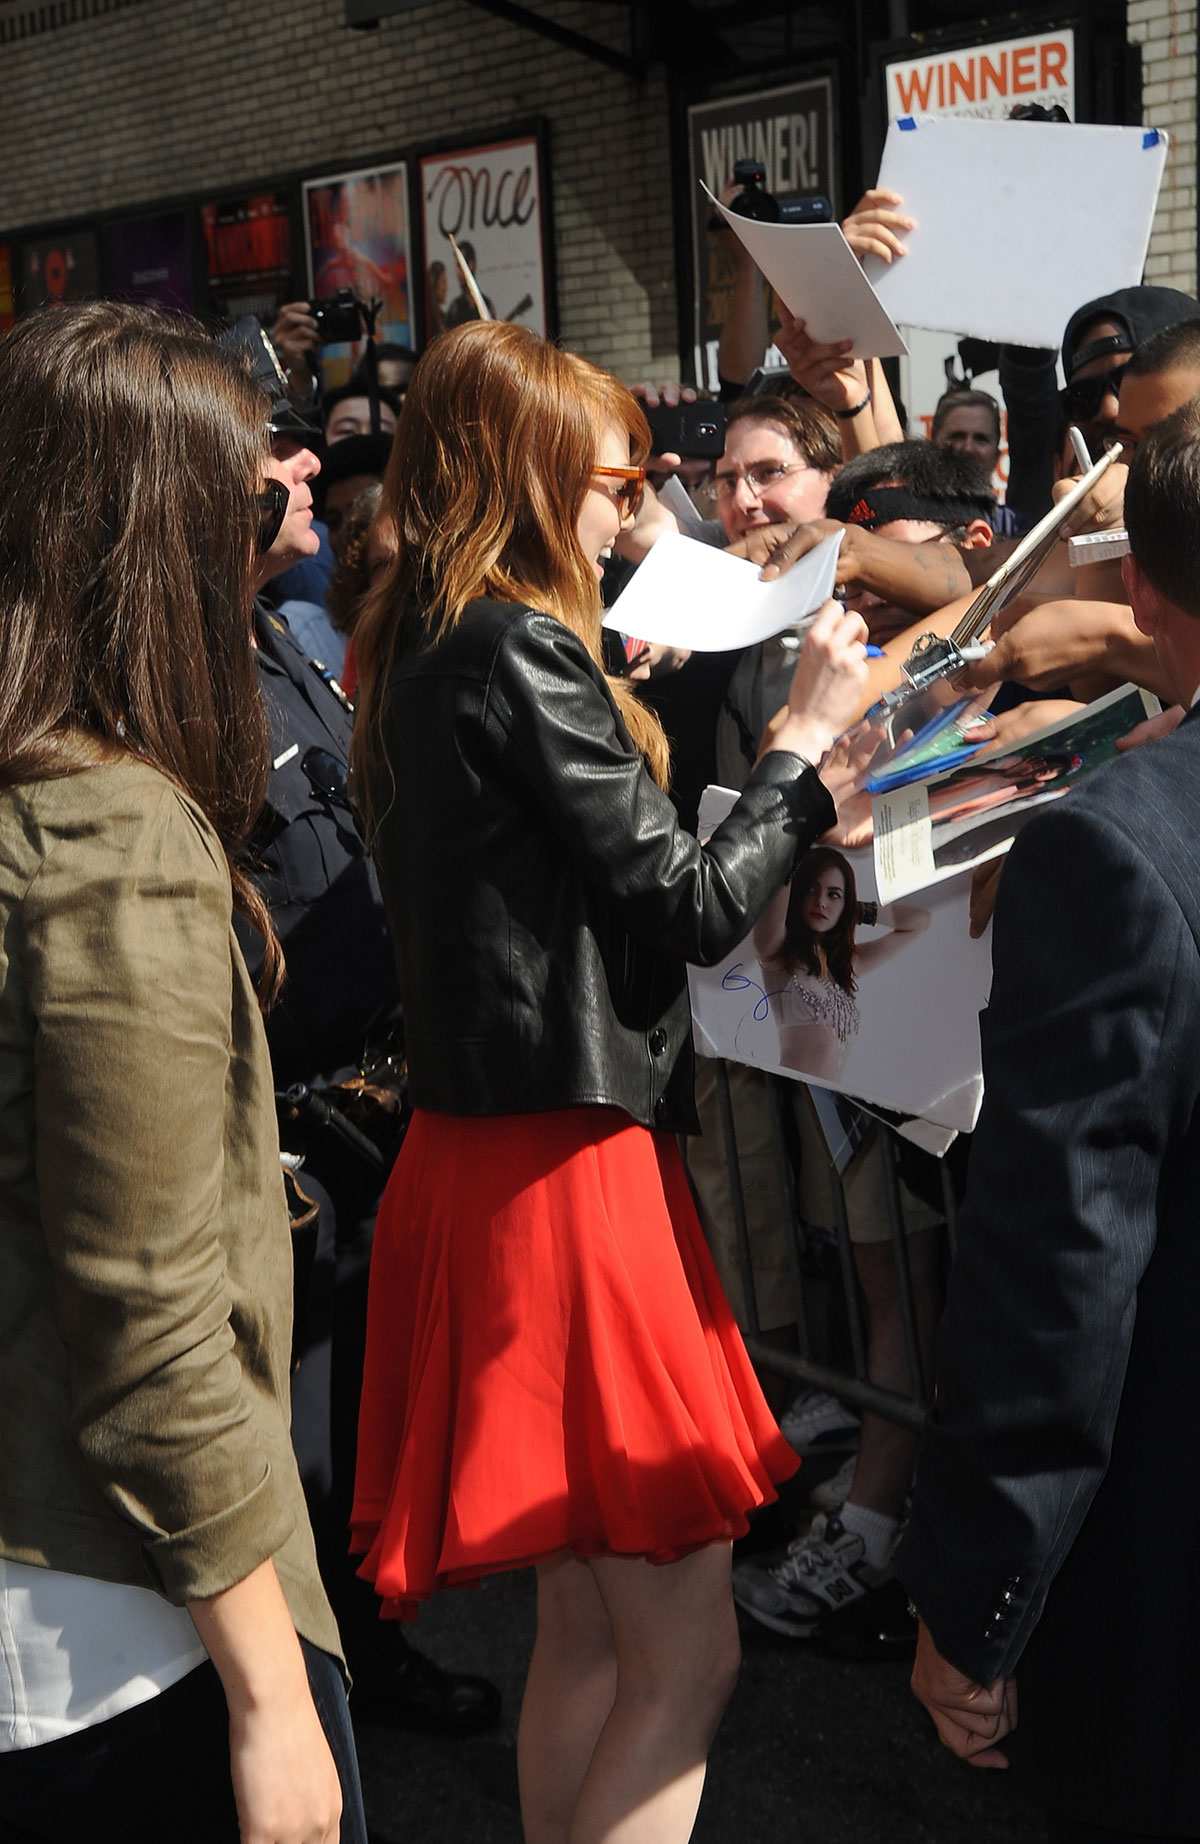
0,302,365,1844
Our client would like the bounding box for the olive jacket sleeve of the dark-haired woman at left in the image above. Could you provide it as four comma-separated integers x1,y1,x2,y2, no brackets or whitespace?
22,787,291,1601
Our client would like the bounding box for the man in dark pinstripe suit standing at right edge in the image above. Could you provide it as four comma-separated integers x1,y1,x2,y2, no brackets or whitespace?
898,400,1200,1844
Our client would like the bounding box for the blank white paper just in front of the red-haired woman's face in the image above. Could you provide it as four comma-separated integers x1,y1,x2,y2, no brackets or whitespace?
603,531,842,653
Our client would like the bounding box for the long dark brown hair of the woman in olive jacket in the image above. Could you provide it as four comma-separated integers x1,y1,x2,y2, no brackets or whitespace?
0,301,282,990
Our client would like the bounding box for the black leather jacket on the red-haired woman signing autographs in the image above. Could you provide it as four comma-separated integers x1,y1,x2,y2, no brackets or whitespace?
371,601,837,1132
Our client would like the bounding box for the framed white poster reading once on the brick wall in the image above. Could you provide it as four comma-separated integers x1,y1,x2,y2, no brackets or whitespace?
420,129,553,339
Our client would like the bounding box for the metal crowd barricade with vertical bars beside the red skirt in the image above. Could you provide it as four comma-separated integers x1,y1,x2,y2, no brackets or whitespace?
715,1062,955,1431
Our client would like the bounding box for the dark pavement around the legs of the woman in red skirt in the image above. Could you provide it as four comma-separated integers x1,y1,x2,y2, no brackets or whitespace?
358,1571,1043,1844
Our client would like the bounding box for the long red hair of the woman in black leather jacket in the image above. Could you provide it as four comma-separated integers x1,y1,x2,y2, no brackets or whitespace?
352,321,667,802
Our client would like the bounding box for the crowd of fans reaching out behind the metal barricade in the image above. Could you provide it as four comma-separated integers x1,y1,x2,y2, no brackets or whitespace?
237,169,1200,1696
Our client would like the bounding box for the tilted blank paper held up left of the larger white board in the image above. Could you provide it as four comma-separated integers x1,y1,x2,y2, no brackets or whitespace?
704,186,909,358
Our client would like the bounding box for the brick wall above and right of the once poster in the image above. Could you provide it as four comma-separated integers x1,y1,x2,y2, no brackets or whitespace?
0,0,678,378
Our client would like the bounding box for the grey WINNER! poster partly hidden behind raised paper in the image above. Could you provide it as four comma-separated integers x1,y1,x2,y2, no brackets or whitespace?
688,76,841,391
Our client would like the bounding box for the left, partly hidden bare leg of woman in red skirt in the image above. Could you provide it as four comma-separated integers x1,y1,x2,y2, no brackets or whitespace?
516,1554,618,1844
